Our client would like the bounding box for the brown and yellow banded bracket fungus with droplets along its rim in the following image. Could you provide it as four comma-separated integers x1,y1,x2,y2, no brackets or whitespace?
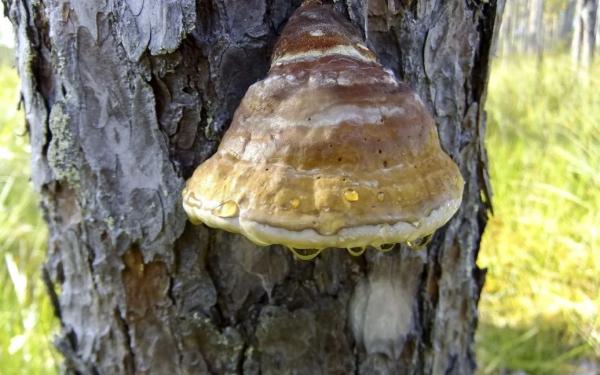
183,0,464,259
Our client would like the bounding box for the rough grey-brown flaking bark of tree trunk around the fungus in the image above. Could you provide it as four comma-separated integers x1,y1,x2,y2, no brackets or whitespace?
3,0,503,374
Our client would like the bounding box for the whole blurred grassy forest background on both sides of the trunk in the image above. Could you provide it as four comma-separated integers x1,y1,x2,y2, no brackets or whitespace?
0,0,600,375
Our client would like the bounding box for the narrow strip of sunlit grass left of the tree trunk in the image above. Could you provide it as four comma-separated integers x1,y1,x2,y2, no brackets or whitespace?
0,65,57,374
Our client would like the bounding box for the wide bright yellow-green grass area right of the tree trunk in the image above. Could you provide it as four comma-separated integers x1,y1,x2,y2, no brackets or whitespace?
478,56,600,374
